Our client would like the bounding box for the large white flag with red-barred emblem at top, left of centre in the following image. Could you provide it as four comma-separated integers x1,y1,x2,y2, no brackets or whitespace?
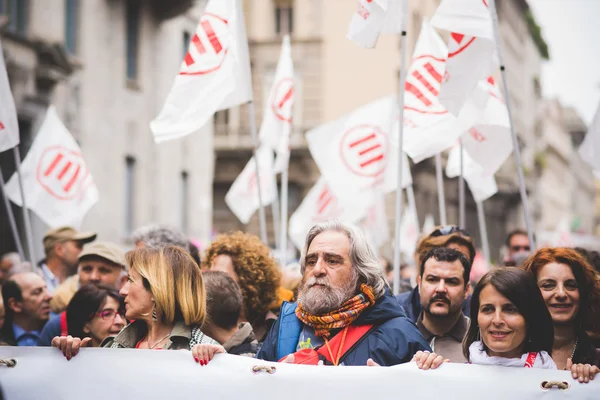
150,0,252,142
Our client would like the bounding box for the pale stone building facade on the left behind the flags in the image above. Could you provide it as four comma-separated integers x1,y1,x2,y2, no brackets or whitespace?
0,0,213,258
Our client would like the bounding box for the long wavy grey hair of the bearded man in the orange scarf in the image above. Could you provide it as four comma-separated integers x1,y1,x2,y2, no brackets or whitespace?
300,219,388,299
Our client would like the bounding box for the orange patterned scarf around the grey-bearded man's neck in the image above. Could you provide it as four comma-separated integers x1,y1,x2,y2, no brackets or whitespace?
296,283,375,337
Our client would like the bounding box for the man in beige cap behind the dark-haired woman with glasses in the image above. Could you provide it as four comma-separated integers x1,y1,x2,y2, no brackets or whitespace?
38,242,128,346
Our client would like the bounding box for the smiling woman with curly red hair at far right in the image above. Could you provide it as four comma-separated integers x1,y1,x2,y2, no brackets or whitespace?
523,247,600,371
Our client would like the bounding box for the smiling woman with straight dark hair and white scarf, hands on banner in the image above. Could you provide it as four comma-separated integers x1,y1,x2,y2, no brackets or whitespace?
414,267,594,382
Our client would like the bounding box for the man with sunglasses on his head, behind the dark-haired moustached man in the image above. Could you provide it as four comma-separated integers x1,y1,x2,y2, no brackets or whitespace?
396,225,475,323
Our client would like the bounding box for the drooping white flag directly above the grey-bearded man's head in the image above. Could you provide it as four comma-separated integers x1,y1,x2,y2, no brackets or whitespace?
289,176,370,250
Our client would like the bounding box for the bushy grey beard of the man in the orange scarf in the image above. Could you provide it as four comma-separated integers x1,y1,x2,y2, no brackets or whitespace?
298,271,358,315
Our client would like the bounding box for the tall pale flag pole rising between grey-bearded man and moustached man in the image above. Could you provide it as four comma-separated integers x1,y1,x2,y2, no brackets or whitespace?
393,1,408,294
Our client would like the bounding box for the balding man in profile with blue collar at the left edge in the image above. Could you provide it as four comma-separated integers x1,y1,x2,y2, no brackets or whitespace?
0,272,52,346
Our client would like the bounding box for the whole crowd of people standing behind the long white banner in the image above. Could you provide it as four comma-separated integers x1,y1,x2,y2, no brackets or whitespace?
0,220,600,382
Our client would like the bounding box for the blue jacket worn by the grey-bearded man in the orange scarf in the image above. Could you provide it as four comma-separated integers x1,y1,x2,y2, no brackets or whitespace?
256,291,431,366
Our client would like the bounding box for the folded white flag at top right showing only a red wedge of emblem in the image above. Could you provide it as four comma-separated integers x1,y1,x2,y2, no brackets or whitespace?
431,0,496,115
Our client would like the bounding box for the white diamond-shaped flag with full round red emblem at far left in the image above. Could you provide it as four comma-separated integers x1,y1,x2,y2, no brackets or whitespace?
6,106,98,227
